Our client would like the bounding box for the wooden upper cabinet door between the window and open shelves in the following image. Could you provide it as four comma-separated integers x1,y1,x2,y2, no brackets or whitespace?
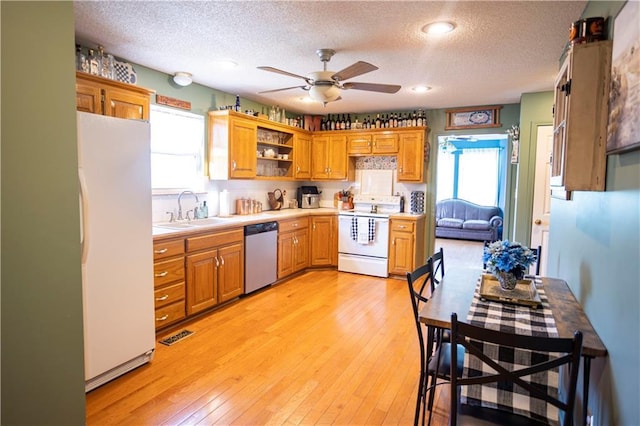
229,119,258,179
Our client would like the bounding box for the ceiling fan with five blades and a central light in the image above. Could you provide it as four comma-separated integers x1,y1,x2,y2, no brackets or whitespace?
258,49,401,105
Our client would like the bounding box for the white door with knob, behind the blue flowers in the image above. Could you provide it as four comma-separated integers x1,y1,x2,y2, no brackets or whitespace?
530,126,553,276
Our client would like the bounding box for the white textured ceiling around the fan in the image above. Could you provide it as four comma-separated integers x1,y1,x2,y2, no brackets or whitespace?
74,0,586,114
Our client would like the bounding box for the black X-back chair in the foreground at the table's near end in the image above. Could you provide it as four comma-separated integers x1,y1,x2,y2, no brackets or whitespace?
449,313,582,426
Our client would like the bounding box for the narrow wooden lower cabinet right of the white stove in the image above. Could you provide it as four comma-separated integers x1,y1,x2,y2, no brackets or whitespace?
389,216,426,275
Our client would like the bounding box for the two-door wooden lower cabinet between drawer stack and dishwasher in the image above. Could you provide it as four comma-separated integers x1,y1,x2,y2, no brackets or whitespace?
186,228,244,315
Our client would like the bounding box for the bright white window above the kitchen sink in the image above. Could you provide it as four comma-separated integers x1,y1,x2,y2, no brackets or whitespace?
149,105,205,190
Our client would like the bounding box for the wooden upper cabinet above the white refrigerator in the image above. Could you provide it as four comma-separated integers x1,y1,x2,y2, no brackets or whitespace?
76,72,153,120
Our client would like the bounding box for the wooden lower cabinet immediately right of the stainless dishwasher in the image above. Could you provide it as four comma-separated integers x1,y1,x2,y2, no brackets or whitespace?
278,217,309,279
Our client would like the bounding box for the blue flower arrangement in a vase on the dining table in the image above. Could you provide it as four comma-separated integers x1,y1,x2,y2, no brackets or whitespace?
482,240,536,280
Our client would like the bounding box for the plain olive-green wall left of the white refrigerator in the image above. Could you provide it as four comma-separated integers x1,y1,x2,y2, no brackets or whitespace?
0,1,85,425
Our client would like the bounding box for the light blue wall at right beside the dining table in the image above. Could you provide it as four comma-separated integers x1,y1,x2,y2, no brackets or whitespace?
548,2,640,425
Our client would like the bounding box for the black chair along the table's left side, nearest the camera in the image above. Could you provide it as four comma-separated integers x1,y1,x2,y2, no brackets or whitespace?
407,258,464,425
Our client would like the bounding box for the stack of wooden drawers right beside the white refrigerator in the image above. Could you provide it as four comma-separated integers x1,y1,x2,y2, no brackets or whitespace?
153,238,186,330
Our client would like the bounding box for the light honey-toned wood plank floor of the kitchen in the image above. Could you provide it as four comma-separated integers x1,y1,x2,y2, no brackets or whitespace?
86,272,452,426
